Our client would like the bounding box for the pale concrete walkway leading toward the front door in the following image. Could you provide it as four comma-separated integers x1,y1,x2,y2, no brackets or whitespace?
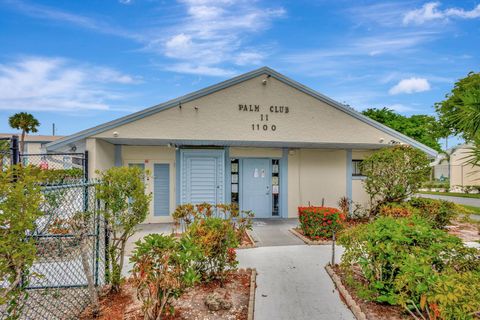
237,245,355,320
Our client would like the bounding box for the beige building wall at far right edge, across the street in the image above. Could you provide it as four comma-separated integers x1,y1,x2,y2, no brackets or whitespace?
450,147,480,188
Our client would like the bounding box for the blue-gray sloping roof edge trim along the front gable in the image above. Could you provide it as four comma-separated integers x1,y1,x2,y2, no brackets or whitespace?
47,67,437,156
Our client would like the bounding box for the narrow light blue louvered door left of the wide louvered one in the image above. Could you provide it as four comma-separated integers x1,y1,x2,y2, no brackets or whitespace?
153,163,170,216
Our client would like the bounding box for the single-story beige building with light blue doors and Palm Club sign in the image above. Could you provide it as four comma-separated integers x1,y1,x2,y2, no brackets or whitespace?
47,67,436,223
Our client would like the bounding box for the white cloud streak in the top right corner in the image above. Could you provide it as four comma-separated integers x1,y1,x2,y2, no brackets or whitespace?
403,2,480,24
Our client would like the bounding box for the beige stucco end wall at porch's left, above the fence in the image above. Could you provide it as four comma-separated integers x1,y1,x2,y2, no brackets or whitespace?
86,138,115,178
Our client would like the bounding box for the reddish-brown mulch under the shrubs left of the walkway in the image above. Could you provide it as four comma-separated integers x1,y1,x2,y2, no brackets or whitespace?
80,269,252,320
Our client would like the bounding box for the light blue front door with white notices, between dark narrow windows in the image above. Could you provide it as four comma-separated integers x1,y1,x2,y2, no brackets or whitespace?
241,159,272,218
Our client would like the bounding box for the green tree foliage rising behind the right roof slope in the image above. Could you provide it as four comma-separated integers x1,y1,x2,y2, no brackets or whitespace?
362,108,448,151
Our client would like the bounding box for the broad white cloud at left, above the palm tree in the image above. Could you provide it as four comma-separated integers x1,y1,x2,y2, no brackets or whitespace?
0,57,138,112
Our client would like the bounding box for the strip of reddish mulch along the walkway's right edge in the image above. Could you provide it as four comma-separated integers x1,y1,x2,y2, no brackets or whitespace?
332,265,411,320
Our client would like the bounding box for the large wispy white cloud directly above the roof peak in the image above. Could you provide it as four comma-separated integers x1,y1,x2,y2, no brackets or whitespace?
146,0,285,75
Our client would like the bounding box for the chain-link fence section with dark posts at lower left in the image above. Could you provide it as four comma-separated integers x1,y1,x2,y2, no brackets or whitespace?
0,182,105,320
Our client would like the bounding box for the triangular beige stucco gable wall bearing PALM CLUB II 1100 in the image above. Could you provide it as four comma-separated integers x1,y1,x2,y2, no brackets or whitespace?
96,76,394,144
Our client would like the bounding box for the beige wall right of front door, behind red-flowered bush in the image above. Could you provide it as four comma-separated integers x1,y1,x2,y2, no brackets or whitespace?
288,149,347,217
